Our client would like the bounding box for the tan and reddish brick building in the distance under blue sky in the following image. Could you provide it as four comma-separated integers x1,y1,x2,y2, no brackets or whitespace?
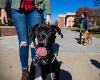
58,12,76,28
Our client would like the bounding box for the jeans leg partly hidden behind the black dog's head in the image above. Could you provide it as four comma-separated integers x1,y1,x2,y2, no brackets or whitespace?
28,9,44,60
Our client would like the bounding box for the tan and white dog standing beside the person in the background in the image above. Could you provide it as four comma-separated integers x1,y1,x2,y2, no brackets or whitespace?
81,31,92,45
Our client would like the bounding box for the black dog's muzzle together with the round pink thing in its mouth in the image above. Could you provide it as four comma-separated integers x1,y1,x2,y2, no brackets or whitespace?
35,32,48,57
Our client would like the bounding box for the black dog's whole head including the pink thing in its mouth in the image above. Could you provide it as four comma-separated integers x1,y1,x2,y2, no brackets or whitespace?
30,24,63,65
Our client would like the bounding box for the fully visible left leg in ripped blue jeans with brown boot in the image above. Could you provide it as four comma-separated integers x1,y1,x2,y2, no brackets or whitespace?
11,9,29,80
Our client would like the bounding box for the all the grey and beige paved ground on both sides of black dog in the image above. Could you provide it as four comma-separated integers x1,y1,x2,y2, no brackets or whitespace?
0,29,100,80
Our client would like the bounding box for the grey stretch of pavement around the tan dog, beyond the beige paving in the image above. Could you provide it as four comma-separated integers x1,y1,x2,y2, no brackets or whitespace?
56,29,100,54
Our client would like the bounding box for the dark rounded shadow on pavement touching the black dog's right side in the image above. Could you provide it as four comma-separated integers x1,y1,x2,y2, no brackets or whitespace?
60,69,72,80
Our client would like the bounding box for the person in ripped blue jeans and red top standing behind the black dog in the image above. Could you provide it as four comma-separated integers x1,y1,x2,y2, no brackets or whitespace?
0,0,51,80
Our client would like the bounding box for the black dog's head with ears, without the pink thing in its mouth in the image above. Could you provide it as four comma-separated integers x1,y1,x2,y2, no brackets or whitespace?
30,24,63,49
